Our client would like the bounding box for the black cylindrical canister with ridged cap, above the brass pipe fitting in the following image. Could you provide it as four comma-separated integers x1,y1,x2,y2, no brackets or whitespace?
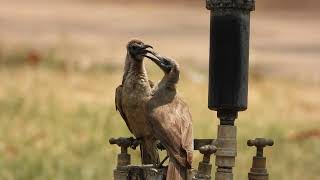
208,0,254,111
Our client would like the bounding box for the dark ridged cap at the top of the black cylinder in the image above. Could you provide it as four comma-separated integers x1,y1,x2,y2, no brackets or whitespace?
206,0,255,11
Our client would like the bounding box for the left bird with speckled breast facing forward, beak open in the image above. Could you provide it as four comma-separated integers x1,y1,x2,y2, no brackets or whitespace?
115,39,159,165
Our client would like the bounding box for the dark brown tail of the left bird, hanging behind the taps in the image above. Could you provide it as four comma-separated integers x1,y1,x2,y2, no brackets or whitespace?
140,138,159,164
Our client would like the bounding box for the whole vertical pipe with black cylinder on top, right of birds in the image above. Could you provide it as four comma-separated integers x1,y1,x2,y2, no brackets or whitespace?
207,0,255,180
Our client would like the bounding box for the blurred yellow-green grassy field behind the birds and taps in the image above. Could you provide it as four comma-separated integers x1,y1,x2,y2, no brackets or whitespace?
0,54,320,180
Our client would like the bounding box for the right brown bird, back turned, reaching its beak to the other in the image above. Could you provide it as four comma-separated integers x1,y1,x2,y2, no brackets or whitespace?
145,52,193,180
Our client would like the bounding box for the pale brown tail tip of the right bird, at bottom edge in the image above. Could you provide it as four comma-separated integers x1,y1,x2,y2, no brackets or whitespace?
166,160,188,180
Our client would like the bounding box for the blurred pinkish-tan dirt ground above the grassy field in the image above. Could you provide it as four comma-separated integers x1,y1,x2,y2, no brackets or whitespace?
0,0,320,81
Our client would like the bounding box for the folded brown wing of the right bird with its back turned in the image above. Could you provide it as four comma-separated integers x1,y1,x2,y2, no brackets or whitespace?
146,95,193,167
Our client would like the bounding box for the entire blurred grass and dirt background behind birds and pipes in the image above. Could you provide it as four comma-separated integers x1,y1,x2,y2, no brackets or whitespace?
0,0,320,180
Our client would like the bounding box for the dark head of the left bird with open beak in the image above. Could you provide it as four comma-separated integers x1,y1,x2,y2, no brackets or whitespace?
127,40,152,61
